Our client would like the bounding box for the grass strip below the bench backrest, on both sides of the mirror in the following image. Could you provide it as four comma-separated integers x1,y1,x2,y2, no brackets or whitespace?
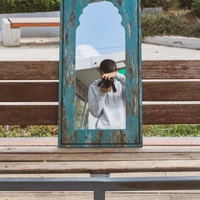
0,125,200,138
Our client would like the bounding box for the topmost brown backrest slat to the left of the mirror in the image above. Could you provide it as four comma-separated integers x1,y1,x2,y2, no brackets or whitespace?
0,61,59,80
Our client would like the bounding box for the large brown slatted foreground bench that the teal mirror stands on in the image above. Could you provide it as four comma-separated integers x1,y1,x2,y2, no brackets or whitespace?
0,60,200,200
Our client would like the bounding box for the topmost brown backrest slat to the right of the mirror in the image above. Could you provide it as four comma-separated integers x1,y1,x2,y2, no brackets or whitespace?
142,60,200,79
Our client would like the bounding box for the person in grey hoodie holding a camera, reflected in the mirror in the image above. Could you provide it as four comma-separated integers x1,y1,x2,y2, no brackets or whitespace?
88,59,126,129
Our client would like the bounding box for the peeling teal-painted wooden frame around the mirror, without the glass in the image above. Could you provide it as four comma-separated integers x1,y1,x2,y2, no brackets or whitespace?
58,0,142,148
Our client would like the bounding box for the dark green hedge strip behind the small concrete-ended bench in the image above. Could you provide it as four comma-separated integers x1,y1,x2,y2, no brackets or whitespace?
0,0,60,14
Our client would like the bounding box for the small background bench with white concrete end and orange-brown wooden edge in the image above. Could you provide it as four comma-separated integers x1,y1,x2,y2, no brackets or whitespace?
2,17,60,47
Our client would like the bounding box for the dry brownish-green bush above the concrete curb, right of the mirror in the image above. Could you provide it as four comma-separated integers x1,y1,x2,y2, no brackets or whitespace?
142,13,200,38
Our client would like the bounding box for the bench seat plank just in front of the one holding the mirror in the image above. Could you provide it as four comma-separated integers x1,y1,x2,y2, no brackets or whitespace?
0,152,200,162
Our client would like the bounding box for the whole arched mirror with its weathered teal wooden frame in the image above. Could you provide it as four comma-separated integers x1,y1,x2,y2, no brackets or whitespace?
58,0,142,148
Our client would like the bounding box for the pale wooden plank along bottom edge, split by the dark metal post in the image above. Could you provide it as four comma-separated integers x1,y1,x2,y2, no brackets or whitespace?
0,190,200,200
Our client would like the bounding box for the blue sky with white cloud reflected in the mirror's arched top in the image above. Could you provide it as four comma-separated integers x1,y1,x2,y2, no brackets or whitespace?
76,1,125,58
